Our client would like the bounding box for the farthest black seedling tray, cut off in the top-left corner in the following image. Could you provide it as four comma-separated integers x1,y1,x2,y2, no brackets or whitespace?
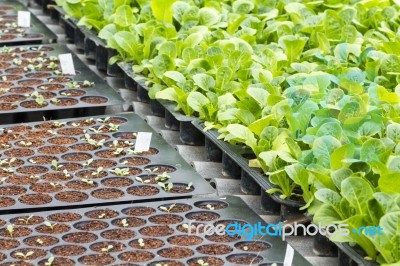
0,0,57,45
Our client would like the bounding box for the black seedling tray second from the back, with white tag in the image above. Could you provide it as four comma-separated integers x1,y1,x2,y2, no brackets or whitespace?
0,44,123,124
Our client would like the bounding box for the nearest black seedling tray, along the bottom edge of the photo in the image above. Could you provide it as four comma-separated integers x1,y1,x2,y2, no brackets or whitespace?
0,196,311,266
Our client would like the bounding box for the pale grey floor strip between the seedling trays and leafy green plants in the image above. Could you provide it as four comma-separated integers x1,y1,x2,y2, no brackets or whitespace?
26,1,338,266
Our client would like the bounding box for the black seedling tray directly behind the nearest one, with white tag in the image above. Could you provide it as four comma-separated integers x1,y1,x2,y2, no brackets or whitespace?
0,113,213,213
